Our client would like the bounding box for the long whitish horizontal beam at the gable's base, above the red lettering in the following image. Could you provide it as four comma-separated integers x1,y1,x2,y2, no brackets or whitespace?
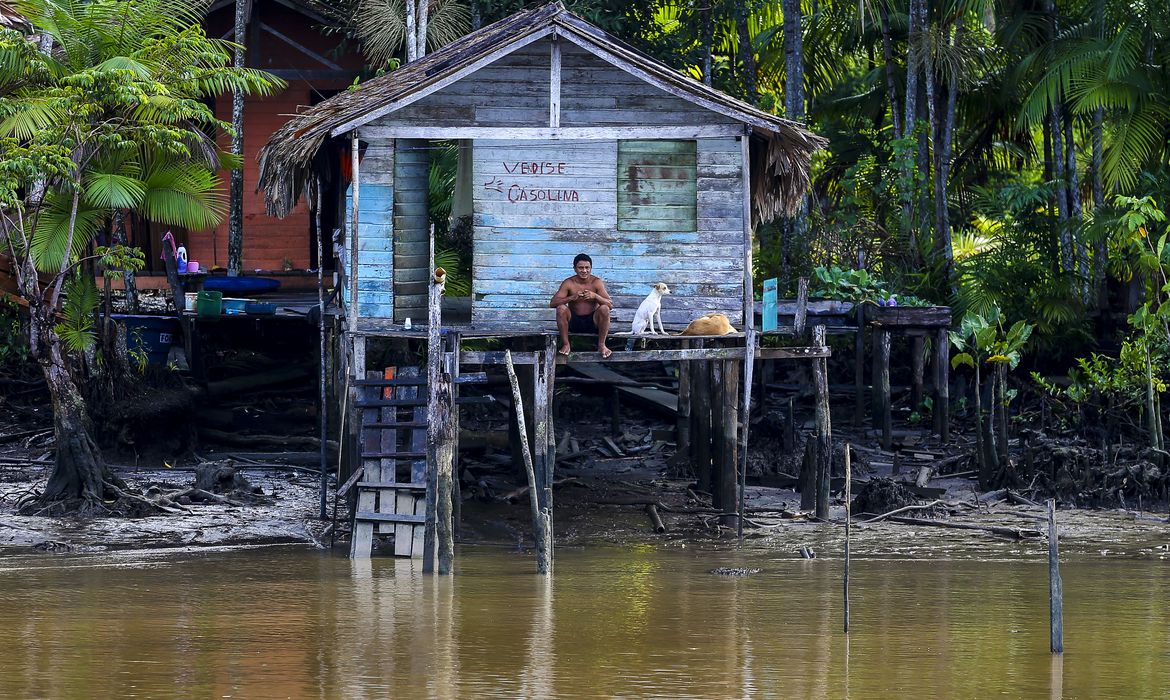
360,124,743,140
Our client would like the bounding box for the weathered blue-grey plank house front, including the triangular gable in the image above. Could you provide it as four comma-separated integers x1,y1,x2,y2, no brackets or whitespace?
359,34,744,330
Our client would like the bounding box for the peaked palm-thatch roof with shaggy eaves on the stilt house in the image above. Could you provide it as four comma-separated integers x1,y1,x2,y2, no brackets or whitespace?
257,2,825,221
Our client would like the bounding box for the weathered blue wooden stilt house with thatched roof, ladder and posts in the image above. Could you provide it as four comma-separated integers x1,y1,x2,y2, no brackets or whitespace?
260,2,830,572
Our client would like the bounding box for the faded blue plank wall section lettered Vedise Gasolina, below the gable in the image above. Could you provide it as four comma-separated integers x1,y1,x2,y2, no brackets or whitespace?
472,138,744,330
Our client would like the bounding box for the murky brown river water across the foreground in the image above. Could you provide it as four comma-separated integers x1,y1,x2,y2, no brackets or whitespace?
0,547,1170,699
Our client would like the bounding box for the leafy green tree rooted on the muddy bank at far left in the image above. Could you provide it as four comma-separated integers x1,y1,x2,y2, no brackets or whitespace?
0,0,281,510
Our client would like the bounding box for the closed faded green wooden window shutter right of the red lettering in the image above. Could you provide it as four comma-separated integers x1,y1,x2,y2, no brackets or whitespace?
618,140,696,231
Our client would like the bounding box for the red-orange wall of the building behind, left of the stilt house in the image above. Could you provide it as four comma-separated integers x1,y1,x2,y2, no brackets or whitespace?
177,0,362,272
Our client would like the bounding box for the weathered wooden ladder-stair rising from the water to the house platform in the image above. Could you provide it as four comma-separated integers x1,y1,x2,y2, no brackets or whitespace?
350,368,427,558
